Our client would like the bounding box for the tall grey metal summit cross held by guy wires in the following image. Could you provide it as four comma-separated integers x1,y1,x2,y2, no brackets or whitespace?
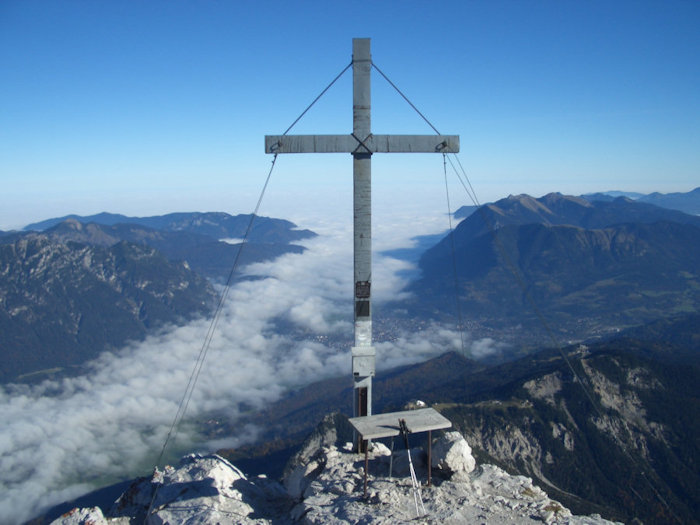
265,38,459,430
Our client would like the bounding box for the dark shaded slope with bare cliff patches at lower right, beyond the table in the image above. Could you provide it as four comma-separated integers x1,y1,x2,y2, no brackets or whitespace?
434,340,700,523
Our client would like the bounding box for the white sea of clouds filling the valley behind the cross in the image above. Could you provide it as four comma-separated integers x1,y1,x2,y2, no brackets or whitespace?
0,207,504,523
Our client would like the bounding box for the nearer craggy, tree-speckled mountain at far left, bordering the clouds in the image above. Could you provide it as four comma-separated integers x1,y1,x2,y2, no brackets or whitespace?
0,234,216,382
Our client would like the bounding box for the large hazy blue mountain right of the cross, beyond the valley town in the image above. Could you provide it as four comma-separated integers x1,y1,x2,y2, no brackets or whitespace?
410,194,700,341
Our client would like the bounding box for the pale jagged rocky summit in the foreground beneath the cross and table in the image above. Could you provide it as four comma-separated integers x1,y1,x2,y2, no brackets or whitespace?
53,418,611,525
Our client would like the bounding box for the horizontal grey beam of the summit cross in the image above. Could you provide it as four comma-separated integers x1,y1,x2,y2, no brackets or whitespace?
265,135,459,153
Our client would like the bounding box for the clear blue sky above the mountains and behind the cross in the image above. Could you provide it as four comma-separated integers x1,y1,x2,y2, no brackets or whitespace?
0,0,700,229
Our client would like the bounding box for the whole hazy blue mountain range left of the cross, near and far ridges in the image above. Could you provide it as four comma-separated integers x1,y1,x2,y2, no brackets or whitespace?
0,213,315,382
